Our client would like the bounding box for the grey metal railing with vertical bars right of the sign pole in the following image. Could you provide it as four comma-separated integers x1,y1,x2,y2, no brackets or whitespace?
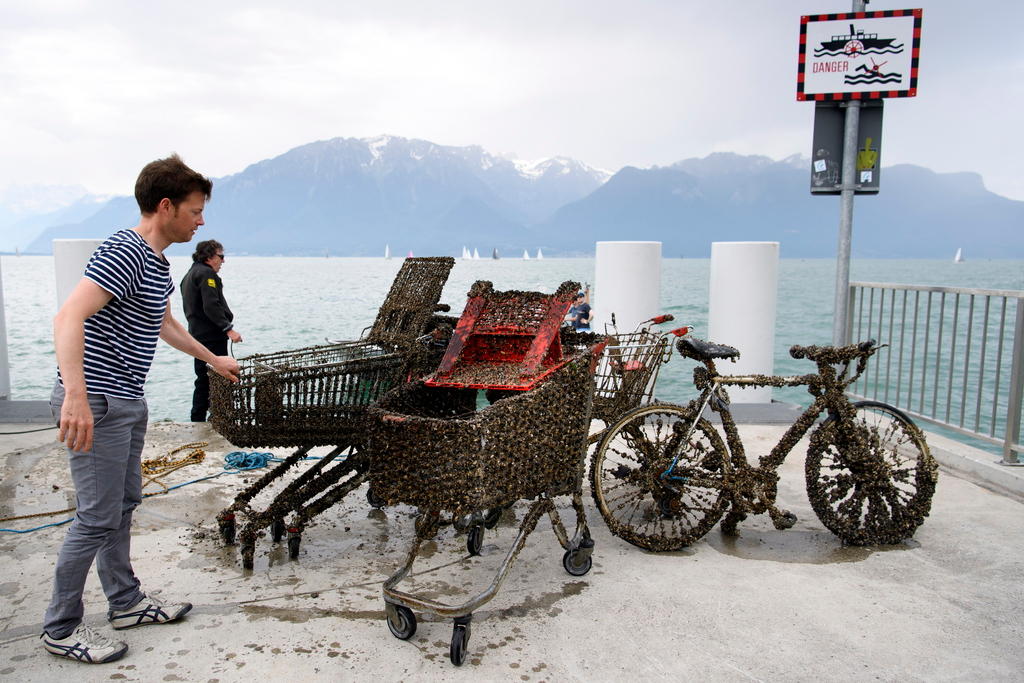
847,283,1024,465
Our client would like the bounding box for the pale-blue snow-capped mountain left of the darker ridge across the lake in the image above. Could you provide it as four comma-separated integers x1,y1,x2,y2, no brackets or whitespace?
33,135,608,255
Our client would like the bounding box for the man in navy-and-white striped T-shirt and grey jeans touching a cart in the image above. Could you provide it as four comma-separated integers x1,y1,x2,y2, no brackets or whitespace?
41,155,239,664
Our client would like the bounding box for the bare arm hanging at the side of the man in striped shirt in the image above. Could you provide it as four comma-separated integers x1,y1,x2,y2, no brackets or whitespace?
53,278,113,452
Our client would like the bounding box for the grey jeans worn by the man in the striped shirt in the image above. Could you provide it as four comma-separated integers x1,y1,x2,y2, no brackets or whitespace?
43,382,150,638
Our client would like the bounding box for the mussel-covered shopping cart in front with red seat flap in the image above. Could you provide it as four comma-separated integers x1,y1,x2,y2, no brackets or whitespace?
369,282,601,666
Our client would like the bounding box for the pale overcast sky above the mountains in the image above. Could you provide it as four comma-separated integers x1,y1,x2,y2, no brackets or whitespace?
0,0,1024,200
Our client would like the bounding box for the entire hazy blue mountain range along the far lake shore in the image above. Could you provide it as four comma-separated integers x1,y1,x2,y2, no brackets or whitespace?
0,136,1024,258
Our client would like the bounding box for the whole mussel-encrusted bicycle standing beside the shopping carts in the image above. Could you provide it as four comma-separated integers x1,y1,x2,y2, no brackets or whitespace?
590,337,938,551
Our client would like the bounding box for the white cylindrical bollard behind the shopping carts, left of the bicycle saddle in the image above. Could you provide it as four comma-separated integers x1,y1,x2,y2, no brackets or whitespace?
591,242,662,333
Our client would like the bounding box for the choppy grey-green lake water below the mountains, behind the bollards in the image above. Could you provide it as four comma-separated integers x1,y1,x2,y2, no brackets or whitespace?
0,250,1024,421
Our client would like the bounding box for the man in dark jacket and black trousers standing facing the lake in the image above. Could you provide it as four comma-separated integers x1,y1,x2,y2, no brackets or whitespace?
181,240,242,422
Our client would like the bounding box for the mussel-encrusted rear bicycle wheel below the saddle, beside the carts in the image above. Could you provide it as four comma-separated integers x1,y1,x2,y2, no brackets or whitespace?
590,404,727,551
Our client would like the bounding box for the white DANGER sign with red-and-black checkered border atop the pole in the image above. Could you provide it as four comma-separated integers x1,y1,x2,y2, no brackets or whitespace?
797,9,922,101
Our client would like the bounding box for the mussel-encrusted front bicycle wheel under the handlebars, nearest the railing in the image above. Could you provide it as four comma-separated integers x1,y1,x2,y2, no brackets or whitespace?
805,400,938,546
